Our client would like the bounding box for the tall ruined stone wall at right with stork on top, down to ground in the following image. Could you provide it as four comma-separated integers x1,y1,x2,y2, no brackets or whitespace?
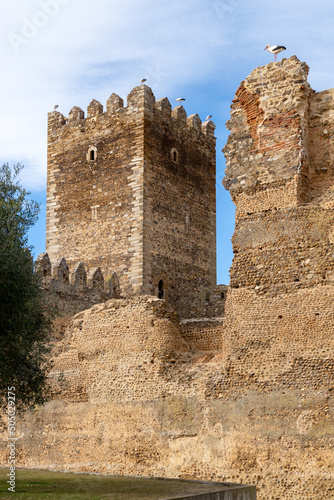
219,57,334,499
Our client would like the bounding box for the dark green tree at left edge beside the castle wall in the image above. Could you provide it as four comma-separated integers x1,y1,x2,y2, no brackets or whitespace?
0,164,48,410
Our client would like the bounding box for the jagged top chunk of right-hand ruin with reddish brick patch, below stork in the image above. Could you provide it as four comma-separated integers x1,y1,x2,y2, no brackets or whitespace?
223,56,313,215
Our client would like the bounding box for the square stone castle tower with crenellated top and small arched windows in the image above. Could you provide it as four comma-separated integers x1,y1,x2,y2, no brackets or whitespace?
46,85,216,316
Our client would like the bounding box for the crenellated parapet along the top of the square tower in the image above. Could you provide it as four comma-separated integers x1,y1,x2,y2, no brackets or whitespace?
48,85,215,138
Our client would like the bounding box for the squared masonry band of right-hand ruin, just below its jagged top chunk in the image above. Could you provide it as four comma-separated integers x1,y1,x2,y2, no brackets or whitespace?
230,205,334,295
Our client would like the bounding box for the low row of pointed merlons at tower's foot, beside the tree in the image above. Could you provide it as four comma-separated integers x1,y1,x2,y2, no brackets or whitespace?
35,253,120,303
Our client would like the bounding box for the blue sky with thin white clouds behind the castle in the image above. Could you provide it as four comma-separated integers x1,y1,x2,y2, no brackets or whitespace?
0,0,334,283
